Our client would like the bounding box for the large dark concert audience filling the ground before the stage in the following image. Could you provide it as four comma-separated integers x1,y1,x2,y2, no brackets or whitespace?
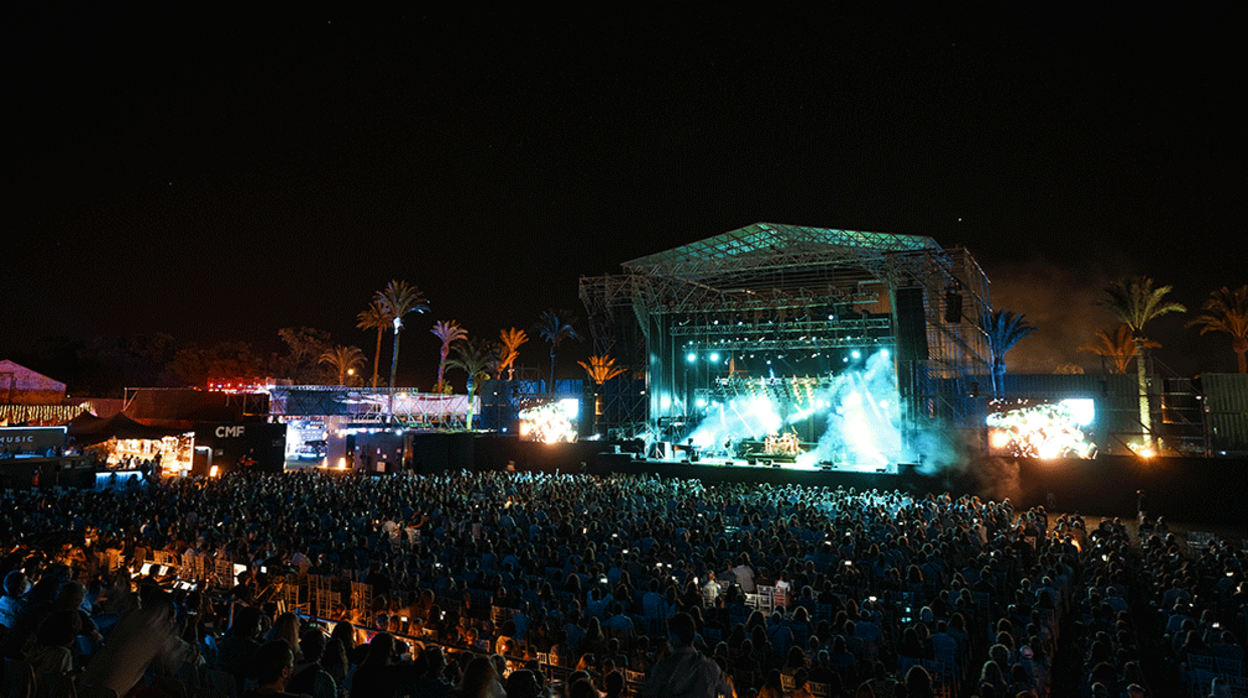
0,471,1248,698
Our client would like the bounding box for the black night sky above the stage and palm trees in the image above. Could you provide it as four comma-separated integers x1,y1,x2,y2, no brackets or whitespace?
7,4,1248,387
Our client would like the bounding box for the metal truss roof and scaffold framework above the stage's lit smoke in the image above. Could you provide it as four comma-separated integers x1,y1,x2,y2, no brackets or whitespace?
580,222,991,442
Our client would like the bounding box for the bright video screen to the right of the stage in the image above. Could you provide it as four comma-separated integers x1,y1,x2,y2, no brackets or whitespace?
987,398,1096,458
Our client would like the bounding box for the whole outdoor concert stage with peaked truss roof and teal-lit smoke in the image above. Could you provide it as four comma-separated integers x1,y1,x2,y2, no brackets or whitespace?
580,222,991,467
